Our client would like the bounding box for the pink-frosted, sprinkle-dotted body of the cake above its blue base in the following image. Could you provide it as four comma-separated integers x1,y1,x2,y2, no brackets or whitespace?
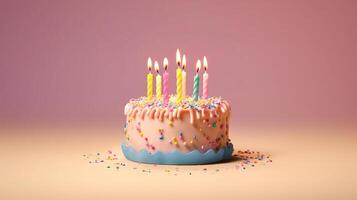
124,96,230,153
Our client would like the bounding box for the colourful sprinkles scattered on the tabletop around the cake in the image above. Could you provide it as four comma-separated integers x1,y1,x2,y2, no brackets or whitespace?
82,149,273,176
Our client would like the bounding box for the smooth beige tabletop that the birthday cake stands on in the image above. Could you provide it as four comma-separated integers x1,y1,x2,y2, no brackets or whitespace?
0,125,357,200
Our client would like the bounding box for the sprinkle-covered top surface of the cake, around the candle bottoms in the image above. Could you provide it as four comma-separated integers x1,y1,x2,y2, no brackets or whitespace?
127,95,228,110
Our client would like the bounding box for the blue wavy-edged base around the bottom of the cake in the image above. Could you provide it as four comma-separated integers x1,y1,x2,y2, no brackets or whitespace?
121,143,233,165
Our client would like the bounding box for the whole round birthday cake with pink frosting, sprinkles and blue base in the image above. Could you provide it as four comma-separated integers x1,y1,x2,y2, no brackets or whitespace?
122,49,233,164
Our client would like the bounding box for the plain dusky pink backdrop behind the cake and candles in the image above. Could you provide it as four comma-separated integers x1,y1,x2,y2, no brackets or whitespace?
0,0,357,124
